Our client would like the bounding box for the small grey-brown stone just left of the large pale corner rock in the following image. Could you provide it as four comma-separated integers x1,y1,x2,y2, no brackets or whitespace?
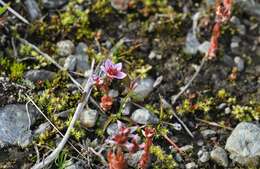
210,147,228,167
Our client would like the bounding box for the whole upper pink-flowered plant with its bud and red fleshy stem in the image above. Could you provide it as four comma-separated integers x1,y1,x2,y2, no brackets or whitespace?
92,59,127,111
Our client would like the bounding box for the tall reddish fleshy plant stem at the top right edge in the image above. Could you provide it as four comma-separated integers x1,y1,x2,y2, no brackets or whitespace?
206,0,232,59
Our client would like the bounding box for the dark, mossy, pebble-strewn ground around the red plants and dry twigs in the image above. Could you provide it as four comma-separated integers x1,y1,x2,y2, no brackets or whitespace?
0,0,260,169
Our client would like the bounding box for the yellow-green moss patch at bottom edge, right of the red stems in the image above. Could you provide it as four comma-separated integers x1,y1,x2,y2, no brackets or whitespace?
150,146,177,169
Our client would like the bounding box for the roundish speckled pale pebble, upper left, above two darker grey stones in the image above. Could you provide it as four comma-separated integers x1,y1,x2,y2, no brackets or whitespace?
57,40,75,57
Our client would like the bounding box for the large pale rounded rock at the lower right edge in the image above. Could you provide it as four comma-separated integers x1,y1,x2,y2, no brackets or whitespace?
225,122,260,166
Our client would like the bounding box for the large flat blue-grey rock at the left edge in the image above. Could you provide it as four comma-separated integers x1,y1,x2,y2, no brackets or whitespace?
0,104,37,148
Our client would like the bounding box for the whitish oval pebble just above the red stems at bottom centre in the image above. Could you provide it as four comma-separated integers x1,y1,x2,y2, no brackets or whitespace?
131,109,159,124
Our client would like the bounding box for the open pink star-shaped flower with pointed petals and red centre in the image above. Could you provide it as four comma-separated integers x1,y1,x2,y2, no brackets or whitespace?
101,59,126,79
